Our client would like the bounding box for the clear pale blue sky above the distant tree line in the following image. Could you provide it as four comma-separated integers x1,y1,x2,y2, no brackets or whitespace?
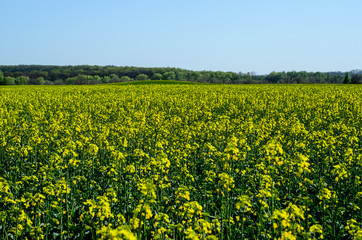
0,0,362,74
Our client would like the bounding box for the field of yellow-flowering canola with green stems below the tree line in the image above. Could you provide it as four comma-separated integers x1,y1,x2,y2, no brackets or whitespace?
0,84,362,240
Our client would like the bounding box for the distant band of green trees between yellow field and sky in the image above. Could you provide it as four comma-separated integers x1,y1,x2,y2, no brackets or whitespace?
0,65,362,85
